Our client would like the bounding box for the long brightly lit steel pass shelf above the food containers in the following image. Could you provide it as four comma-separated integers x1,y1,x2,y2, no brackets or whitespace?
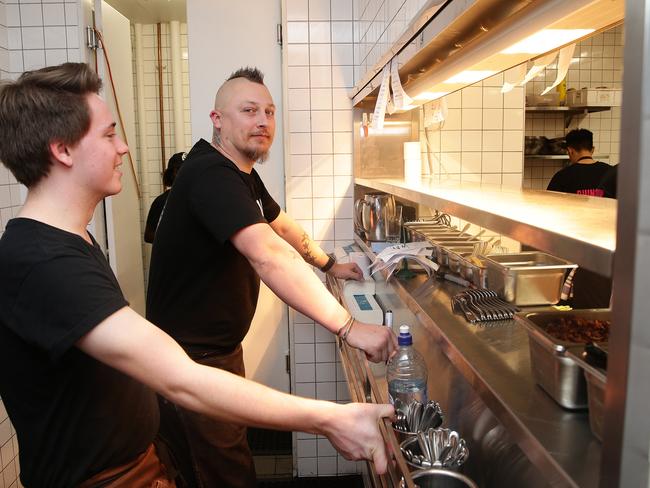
355,177,616,276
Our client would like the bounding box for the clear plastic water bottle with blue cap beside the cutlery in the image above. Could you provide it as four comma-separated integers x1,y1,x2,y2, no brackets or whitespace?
386,325,428,405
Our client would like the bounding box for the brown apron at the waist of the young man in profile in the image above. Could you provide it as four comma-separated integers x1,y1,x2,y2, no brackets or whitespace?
79,444,176,488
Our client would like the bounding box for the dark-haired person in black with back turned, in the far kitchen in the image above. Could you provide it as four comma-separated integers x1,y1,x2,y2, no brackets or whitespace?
547,129,612,197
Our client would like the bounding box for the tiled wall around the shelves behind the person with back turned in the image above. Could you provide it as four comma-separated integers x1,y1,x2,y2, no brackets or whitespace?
523,26,623,189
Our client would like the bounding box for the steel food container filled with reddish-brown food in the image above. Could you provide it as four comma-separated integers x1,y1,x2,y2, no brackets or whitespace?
515,310,610,409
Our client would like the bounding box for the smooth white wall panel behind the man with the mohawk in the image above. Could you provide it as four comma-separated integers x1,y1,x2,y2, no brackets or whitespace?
187,0,289,391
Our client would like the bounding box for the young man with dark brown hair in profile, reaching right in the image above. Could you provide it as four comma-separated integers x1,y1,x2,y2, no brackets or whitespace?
0,63,393,488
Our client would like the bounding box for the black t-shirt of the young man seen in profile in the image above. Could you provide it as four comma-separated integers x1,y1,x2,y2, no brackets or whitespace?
0,218,159,488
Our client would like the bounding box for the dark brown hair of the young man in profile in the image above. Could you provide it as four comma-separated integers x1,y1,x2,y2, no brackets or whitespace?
0,63,102,188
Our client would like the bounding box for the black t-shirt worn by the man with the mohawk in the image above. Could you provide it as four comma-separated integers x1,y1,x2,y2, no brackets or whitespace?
147,139,280,358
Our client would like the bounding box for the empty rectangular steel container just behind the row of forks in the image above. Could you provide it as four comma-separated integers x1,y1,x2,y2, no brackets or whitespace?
485,251,577,306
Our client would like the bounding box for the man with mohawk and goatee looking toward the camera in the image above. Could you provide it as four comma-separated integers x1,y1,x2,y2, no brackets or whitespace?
147,68,397,488
